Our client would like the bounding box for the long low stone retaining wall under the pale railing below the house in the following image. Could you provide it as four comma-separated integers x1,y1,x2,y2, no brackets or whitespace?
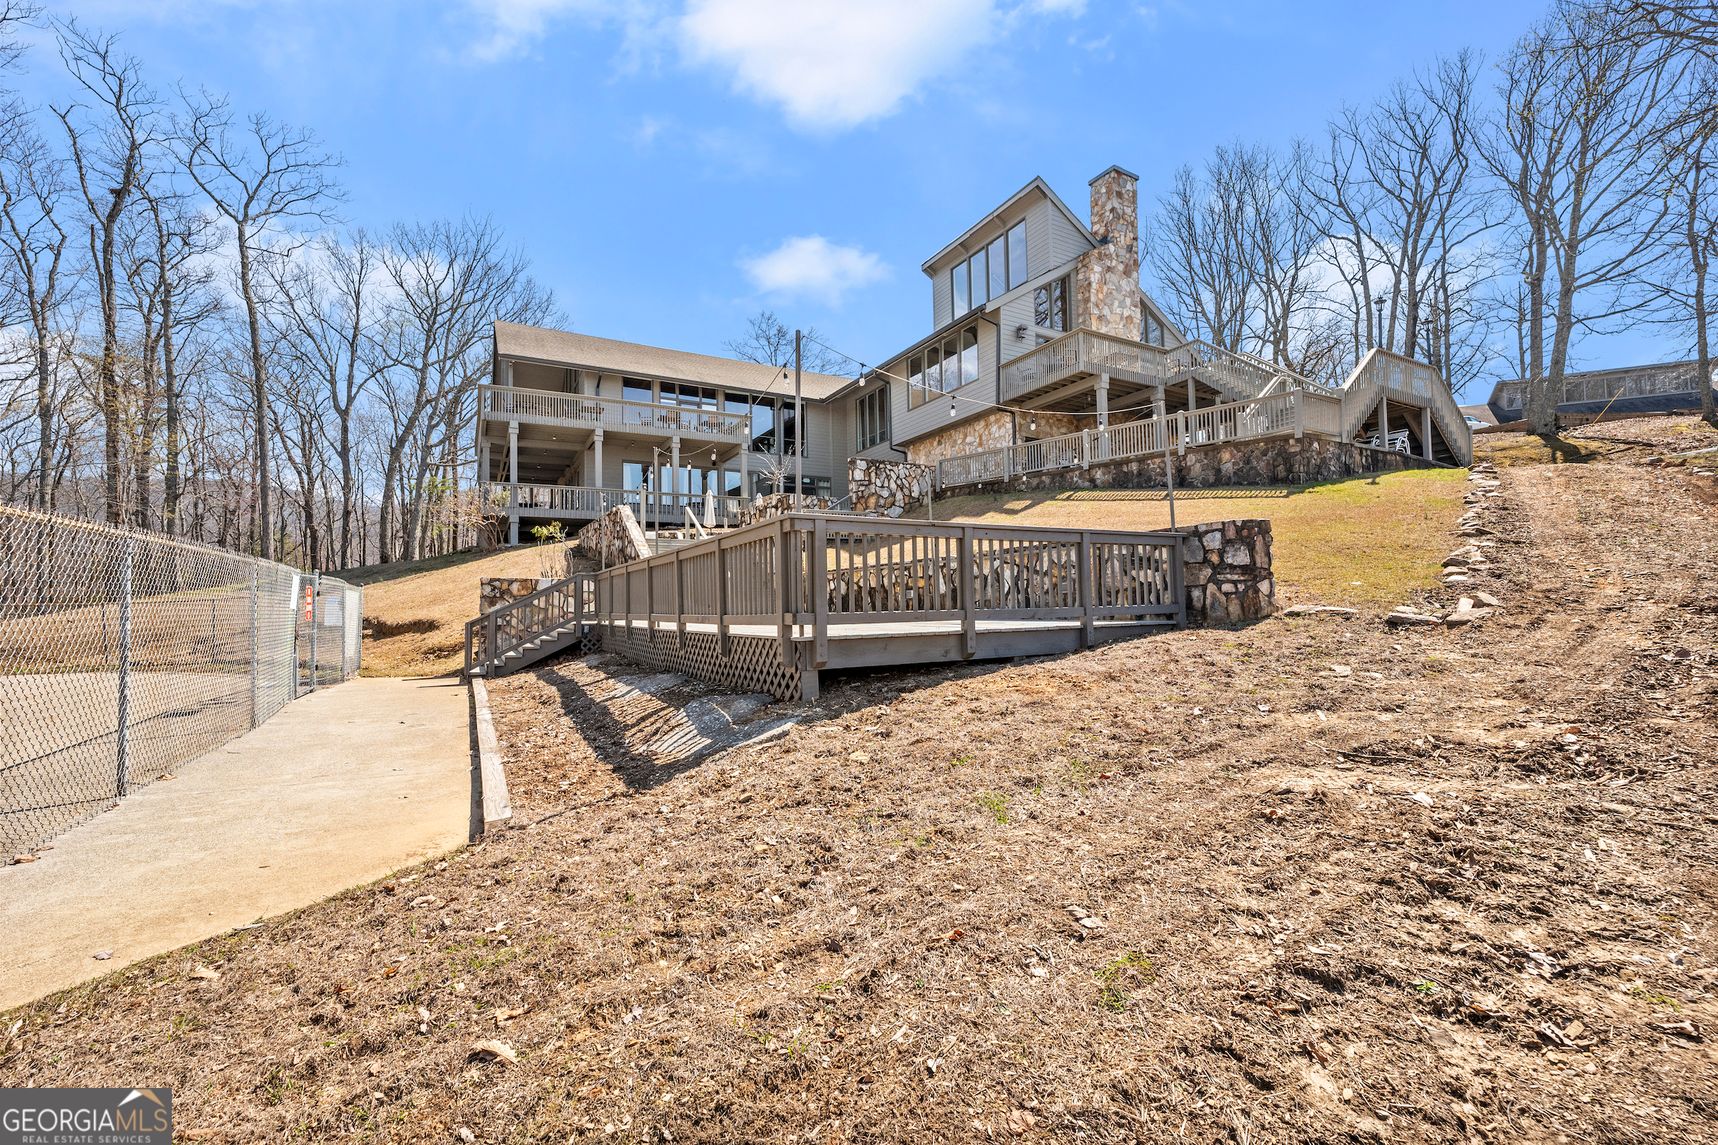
938,435,1431,495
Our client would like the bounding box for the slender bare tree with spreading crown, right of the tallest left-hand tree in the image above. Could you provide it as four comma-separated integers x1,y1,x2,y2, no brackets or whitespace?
175,93,338,557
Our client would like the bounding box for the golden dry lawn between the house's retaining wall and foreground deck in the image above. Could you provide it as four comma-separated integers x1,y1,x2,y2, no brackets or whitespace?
936,469,1467,605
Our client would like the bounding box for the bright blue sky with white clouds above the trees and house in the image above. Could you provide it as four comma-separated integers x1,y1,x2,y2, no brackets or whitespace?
36,0,1673,391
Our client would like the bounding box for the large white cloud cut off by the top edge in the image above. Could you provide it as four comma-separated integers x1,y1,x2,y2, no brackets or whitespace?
680,0,993,129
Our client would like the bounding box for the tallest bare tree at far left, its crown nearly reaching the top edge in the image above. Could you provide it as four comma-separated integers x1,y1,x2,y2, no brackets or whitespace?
53,21,156,524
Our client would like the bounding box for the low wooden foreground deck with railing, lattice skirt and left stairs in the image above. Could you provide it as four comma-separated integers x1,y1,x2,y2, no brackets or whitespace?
467,514,1187,700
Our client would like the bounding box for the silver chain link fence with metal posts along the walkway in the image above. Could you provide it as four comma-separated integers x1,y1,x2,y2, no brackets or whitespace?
0,507,362,861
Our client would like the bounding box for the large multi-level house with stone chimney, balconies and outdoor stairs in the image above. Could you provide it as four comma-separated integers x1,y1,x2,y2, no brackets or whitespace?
476,167,1472,542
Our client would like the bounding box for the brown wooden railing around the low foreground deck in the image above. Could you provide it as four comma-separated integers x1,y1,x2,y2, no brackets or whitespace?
594,514,1185,667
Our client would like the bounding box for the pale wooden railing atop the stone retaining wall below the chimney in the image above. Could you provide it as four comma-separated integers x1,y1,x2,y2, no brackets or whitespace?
936,389,1342,488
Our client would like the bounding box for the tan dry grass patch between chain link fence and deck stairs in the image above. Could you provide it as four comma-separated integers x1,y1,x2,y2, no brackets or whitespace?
355,543,565,676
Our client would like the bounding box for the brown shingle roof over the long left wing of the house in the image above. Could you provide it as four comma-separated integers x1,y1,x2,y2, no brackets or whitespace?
495,321,852,401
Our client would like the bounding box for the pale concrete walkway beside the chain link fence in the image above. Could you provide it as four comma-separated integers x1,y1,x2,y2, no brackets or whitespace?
0,679,472,1011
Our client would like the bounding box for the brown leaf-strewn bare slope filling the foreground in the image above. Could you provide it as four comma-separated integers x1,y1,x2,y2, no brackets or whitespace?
0,434,1718,1145
